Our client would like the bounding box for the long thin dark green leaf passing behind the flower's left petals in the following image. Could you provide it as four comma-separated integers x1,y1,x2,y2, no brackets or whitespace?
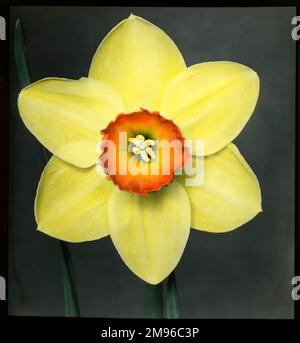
14,19,80,317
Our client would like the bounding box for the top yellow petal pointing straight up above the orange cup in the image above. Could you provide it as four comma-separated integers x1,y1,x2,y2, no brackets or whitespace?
89,15,185,112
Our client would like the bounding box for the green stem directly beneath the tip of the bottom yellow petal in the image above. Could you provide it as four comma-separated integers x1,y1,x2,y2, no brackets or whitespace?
145,282,164,318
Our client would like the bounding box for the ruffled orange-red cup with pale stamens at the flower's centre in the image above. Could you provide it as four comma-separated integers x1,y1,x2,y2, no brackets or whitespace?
99,108,189,195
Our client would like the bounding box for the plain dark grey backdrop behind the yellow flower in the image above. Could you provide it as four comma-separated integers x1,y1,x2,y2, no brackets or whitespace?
9,7,295,318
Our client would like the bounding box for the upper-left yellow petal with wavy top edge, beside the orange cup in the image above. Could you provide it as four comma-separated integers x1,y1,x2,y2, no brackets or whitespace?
18,78,124,168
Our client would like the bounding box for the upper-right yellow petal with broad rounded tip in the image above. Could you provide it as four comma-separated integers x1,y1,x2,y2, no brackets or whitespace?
161,62,259,155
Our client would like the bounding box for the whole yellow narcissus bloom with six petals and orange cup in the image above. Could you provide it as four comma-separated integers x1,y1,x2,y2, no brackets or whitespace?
18,15,261,284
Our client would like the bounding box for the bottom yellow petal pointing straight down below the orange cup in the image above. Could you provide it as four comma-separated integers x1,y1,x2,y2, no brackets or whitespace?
108,182,191,284
